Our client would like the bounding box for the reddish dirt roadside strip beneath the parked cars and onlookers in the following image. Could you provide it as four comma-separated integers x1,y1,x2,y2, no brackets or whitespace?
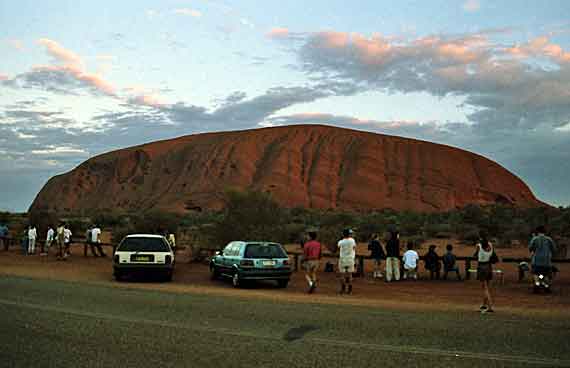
0,241,570,317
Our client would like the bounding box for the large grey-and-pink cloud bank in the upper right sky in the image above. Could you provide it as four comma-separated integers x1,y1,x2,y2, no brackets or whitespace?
297,32,570,129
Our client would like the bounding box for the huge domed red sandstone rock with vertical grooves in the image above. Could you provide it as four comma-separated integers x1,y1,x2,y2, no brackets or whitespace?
30,125,543,212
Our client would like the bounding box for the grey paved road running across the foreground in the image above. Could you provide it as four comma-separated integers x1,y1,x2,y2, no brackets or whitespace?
0,276,570,368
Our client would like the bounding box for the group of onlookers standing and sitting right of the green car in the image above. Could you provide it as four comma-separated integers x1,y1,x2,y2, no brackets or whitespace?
303,226,557,313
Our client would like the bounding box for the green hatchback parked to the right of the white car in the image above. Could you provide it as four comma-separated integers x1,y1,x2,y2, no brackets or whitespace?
210,241,291,288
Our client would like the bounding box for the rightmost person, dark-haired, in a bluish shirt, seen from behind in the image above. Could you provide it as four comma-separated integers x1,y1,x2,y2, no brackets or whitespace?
528,226,557,292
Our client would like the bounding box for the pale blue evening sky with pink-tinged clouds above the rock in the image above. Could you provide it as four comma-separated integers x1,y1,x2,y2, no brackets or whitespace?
0,0,570,212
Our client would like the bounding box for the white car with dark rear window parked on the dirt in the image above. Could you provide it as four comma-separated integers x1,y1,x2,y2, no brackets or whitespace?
113,234,174,281
